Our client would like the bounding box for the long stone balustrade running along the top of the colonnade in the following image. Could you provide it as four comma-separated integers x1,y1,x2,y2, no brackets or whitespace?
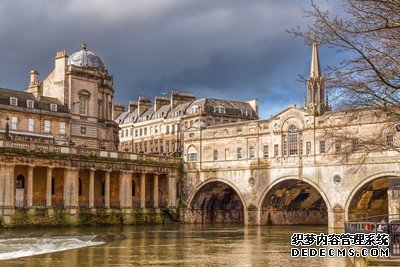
0,139,181,163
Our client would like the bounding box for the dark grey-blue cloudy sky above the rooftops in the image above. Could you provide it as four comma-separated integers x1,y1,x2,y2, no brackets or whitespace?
0,0,337,118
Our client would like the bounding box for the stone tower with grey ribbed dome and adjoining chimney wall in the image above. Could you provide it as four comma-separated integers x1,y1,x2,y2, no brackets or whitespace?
43,44,118,149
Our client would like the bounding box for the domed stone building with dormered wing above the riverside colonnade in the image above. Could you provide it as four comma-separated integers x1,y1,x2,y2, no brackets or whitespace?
0,44,118,150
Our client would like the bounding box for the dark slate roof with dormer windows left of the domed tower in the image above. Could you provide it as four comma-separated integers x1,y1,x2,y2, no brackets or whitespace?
0,88,69,113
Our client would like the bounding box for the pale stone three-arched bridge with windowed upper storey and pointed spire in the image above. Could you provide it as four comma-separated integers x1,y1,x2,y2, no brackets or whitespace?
182,41,400,228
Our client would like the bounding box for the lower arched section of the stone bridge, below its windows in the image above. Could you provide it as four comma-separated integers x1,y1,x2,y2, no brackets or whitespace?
184,154,400,228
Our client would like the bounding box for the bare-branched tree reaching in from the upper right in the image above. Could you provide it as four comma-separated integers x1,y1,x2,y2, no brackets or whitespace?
290,0,400,156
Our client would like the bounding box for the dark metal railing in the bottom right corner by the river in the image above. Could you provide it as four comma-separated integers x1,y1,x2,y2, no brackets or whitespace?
345,220,400,257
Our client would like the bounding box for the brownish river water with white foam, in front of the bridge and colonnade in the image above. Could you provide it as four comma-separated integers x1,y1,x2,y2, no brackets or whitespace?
0,224,348,267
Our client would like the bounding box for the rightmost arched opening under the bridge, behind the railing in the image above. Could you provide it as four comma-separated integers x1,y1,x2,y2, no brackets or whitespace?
347,177,389,222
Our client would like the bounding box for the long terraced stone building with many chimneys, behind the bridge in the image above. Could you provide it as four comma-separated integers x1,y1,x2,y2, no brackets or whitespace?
114,91,258,154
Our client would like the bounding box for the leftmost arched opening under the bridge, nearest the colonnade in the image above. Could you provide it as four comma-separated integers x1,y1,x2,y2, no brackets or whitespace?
189,181,244,223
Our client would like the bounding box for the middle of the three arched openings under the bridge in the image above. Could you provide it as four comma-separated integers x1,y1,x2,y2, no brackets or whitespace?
260,179,328,225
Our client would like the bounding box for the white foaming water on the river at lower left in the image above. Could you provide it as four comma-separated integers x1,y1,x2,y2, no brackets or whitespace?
0,236,105,260
